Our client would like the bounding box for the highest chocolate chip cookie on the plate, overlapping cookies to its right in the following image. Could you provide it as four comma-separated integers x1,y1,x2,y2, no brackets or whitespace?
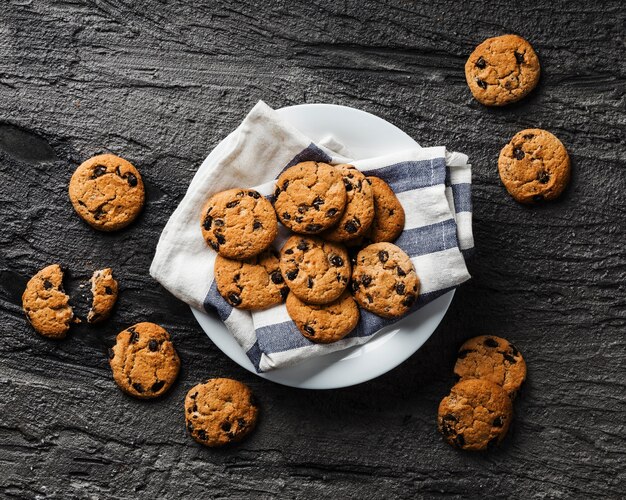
274,161,346,234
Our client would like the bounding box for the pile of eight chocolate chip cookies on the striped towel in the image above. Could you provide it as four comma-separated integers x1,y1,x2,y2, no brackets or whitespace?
201,161,419,343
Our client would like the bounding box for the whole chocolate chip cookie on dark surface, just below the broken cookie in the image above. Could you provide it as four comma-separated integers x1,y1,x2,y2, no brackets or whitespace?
109,322,180,399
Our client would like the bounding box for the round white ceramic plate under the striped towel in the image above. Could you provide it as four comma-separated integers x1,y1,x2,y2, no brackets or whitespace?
192,104,454,389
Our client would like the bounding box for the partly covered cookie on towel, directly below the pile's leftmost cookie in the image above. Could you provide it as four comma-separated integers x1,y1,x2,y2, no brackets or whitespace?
215,248,289,310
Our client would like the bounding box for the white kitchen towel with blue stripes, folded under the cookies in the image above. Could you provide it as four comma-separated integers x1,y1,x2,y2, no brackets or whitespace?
150,102,474,372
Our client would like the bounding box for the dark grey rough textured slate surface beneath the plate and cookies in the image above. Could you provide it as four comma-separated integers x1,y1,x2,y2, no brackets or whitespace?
0,0,626,499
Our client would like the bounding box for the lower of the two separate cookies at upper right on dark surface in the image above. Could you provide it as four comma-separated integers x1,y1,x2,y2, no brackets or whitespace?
498,128,571,204
